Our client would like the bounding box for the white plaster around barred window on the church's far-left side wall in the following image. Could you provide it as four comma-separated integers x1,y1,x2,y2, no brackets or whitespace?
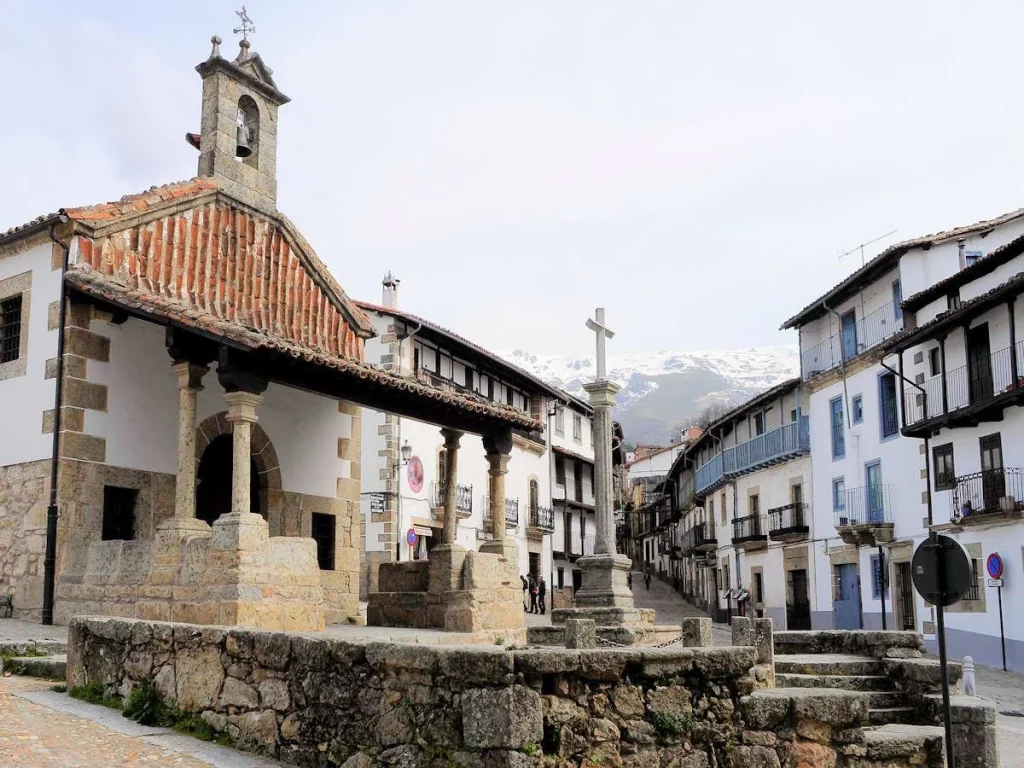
0,240,60,467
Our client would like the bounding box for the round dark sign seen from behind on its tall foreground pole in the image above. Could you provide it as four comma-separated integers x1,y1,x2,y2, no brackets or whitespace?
911,530,970,768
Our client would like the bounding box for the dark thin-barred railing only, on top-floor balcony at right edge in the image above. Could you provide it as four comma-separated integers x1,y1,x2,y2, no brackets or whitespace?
903,341,1024,426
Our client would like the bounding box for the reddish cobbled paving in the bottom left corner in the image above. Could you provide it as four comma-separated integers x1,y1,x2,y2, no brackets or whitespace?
0,675,282,768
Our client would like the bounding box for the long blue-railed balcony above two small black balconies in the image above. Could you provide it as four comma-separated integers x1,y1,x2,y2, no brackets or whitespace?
693,416,811,499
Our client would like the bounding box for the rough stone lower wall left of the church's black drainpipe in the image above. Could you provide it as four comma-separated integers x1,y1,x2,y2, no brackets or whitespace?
0,461,50,621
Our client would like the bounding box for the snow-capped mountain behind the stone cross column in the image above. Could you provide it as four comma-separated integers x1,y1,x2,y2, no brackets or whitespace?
499,345,800,443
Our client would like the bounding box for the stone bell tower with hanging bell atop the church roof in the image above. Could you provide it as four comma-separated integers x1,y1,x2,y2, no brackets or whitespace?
186,35,290,211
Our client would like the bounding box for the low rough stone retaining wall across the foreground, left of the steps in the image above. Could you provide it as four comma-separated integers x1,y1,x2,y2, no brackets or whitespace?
68,618,935,768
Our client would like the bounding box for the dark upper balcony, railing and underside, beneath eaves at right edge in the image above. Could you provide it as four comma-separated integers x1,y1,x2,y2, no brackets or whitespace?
903,341,1024,437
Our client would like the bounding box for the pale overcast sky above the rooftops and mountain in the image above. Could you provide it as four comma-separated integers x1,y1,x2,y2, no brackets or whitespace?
0,0,1024,354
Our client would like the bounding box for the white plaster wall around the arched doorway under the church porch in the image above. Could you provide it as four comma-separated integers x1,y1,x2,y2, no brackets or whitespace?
85,318,351,498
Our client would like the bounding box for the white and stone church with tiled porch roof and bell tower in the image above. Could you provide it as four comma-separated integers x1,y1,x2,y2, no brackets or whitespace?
0,37,543,630
